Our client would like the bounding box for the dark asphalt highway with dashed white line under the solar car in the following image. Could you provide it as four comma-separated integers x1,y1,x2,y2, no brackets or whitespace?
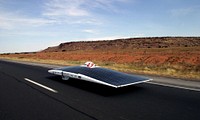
0,61,200,120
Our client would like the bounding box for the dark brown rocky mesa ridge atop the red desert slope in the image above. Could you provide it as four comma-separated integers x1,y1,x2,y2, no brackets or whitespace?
43,37,200,52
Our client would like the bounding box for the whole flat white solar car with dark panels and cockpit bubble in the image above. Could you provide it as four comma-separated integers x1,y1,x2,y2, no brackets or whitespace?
48,62,152,88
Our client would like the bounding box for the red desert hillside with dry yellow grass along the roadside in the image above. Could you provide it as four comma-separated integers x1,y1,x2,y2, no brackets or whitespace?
0,37,200,80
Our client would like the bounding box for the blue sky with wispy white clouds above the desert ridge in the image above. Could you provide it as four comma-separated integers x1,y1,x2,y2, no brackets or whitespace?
0,0,200,53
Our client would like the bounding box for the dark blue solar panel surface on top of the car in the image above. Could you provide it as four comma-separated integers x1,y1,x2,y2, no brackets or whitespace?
59,66,148,86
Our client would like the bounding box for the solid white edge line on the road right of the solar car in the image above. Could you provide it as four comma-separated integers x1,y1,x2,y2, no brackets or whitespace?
147,82,200,92
